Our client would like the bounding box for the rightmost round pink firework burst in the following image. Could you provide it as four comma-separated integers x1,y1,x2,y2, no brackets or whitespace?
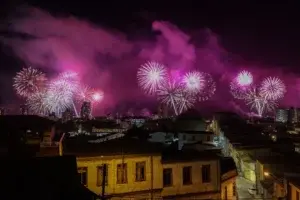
259,77,286,101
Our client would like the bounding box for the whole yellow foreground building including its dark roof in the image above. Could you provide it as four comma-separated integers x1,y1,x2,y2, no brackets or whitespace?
58,138,236,200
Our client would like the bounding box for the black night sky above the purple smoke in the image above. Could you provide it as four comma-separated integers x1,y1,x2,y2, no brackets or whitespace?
0,0,300,111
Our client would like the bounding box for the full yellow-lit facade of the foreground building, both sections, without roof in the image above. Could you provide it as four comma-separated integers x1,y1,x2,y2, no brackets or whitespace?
77,154,223,199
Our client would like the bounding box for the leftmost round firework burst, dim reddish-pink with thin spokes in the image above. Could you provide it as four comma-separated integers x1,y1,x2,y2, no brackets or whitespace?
13,67,47,97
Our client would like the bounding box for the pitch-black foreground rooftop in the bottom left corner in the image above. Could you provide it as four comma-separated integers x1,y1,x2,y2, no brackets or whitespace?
0,156,96,200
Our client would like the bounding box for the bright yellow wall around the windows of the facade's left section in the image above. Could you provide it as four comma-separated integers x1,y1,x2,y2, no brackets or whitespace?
77,155,162,198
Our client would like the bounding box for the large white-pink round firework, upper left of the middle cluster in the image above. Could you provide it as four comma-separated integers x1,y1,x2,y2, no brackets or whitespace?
137,62,167,94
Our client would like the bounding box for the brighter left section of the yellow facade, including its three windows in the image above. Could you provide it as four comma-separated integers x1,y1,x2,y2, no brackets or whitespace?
77,155,162,199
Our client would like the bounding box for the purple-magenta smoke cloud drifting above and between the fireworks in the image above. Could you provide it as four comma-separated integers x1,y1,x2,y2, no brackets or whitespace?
0,7,300,114
